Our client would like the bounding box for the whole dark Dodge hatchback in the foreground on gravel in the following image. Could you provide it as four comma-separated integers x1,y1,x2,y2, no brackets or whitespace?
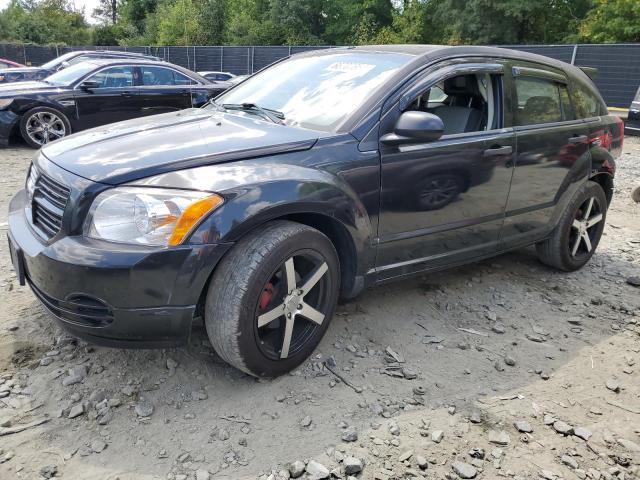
9,45,623,376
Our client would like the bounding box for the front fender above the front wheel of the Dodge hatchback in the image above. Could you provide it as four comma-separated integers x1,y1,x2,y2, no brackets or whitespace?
134,150,378,284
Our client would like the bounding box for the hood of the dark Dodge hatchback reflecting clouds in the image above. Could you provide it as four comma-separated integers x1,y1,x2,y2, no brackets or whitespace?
42,108,326,185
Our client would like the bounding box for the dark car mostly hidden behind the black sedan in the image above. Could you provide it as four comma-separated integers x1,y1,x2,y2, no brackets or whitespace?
0,50,160,84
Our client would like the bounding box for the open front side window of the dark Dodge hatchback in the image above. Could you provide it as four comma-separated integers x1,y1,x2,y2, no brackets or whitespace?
408,73,502,135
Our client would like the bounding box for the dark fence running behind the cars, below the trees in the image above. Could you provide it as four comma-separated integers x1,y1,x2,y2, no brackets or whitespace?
0,44,640,108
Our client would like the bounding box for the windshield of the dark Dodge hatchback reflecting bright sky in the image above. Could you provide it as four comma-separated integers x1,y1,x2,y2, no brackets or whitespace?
216,52,412,131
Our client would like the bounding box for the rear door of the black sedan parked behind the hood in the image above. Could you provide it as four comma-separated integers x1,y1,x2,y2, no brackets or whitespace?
140,65,192,115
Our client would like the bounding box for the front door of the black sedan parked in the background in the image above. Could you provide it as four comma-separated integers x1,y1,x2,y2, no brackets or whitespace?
75,65,141,130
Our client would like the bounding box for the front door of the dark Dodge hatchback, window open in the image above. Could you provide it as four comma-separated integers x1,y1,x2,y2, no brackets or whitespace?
376,63,515,280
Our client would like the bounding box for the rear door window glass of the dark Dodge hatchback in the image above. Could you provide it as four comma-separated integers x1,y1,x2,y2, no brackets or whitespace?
515,76,575,126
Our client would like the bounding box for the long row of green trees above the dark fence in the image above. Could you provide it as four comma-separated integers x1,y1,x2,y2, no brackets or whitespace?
0,0,640,45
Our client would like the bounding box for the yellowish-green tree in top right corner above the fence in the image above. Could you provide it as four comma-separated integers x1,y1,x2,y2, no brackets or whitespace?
579,0,640,43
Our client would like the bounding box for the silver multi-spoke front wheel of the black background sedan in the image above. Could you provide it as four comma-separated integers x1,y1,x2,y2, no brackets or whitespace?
20,107,71,148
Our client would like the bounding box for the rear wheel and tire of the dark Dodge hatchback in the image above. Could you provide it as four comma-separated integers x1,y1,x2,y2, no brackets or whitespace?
536,181,607,272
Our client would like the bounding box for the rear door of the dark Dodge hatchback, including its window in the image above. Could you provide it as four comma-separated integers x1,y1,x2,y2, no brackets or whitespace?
502,62,590,248
